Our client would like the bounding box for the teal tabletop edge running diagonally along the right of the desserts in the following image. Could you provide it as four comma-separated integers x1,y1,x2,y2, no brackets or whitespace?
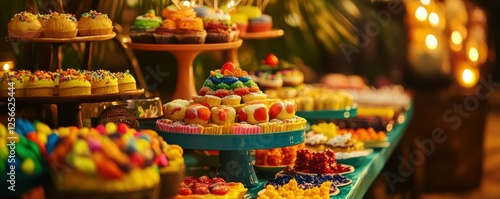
245,107,413,199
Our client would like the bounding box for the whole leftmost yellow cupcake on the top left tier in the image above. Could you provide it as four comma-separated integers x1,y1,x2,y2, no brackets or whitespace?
7,12,43,38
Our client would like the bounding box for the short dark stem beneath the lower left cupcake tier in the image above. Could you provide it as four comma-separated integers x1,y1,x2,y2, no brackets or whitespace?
57,104,83,128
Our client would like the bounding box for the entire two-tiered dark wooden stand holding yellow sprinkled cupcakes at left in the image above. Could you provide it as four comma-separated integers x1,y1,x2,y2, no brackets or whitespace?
5,32,144,127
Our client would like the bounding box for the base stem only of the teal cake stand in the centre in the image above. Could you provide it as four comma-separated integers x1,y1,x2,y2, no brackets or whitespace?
217,150,259,188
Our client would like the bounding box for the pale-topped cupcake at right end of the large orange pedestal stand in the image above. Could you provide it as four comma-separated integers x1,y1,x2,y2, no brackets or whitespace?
204,12,234,43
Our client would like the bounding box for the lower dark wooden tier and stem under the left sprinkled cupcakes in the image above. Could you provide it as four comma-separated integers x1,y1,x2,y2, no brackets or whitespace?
0,89,144,128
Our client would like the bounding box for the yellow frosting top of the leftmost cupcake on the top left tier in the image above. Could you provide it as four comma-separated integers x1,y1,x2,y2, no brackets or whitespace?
8,12,42,31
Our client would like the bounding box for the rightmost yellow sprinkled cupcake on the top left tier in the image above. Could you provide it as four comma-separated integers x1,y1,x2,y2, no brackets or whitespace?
78,10,113,36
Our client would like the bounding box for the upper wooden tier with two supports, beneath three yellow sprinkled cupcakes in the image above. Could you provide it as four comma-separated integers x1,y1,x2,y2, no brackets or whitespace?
7,32,116,71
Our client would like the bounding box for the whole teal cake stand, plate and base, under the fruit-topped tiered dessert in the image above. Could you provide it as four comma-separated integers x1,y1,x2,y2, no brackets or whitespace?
156,129,305,188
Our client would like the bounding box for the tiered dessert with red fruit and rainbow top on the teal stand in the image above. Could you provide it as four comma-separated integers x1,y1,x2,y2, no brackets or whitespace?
156,62,306,134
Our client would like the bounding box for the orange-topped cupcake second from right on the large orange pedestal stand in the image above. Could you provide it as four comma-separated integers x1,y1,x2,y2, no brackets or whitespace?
175,18,207,44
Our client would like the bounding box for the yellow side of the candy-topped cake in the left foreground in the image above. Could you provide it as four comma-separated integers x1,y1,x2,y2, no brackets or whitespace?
54,167,160,192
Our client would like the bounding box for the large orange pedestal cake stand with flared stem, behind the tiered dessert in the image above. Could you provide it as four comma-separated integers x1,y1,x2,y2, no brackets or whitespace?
127,40,243,100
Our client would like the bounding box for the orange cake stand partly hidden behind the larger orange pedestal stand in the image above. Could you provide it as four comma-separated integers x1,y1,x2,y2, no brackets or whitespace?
225,29,285,66
